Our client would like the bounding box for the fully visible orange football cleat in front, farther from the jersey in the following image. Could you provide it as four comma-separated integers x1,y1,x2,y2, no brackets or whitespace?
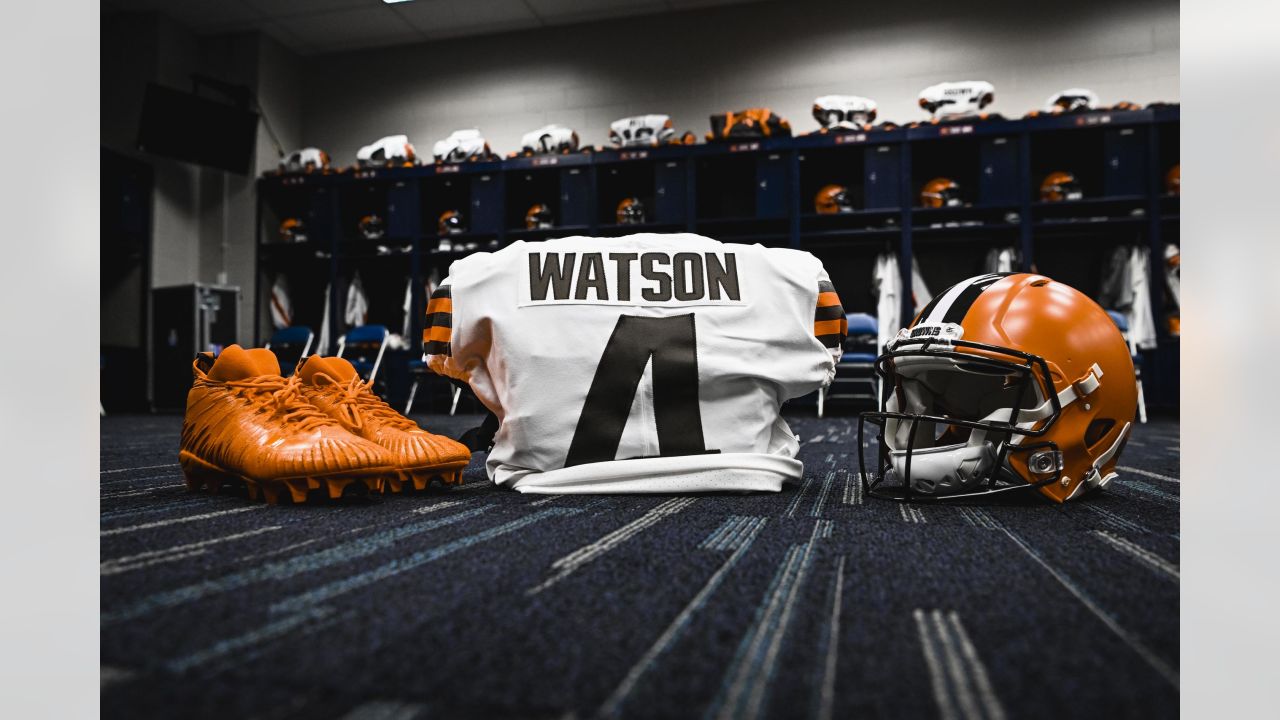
178,345,396,502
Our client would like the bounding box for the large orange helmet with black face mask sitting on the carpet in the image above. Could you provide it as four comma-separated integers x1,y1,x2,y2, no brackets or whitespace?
858,273,1138,502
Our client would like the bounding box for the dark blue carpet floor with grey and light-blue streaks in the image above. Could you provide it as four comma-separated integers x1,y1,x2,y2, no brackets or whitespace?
101,416,1180,720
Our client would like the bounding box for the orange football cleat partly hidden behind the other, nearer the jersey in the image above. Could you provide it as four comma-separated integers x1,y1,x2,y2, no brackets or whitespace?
294,355,471,492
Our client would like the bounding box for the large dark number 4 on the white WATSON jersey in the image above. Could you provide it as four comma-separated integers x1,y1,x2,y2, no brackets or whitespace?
564,313,707,468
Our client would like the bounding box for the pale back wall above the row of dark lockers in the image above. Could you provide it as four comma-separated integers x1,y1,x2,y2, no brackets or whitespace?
302,0,1179,164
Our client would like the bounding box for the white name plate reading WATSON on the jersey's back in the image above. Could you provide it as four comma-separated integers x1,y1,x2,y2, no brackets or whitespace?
518,250,744,307
